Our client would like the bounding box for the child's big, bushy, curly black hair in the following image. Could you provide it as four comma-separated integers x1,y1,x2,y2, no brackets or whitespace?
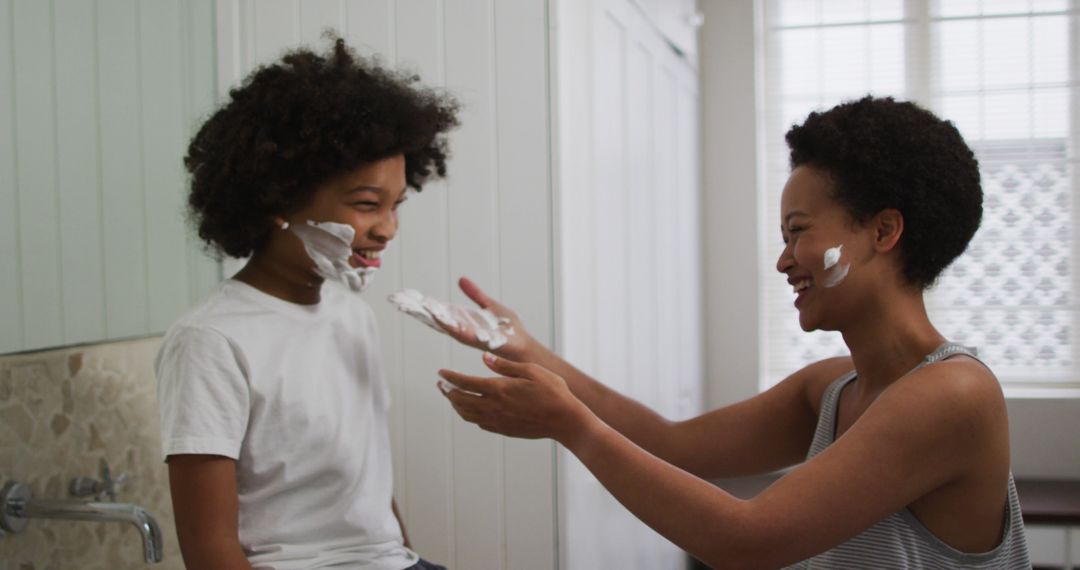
184,35,458,257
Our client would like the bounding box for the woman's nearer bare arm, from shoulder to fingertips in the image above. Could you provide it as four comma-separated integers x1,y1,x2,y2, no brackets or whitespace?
441,358,988,568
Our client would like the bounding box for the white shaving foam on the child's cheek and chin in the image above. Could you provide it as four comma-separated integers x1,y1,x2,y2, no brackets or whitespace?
289,220,378,293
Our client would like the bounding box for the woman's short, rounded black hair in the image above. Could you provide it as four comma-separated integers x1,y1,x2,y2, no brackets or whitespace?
786,96,983,289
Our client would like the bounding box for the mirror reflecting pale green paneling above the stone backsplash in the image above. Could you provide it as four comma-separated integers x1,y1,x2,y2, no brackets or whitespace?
0,0,219,353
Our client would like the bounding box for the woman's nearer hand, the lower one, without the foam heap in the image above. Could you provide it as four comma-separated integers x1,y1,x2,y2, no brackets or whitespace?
438,353,599,445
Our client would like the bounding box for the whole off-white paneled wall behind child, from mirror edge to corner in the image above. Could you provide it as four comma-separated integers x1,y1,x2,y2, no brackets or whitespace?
217,0,556,570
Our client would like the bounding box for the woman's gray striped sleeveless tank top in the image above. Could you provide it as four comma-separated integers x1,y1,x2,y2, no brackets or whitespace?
789,343,1031,570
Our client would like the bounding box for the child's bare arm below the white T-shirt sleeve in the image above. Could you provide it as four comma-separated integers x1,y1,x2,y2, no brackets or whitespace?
168,454,252,570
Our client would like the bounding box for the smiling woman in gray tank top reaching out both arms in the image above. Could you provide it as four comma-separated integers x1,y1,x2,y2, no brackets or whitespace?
429,97,1030,569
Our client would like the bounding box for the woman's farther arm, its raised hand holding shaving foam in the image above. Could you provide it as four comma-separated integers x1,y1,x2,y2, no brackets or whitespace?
434,277,852,478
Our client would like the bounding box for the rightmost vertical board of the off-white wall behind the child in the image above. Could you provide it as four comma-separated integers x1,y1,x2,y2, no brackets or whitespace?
495,1,556,569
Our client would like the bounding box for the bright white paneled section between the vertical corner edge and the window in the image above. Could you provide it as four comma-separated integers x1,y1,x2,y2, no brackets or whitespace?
555,0,703,570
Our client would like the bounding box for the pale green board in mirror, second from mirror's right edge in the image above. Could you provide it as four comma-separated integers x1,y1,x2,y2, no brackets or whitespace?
139,0,189,330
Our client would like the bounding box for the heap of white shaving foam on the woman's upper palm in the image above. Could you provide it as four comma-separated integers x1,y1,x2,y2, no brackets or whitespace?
388,289,514,350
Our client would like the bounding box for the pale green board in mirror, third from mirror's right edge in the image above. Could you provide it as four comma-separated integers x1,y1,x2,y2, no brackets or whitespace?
97,0,148,338
